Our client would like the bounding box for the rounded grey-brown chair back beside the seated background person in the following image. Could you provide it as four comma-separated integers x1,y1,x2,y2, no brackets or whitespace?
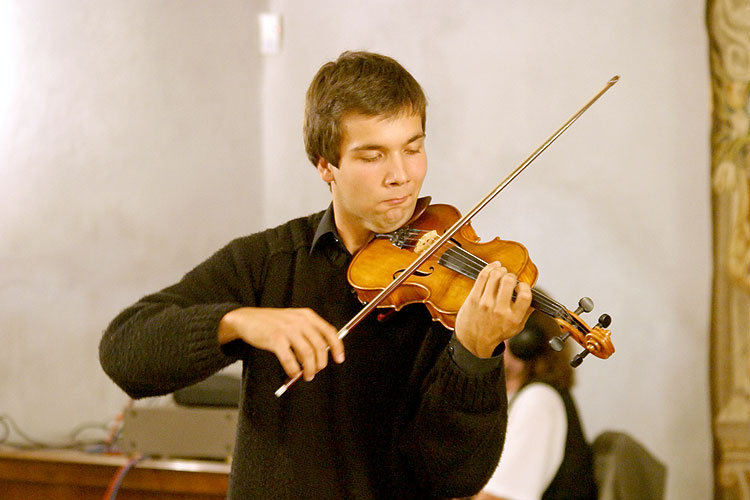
592,431,667,500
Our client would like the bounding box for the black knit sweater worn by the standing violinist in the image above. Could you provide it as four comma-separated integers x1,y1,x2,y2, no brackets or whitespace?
100,208,507,500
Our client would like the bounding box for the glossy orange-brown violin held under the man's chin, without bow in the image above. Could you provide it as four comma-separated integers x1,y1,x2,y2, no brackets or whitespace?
347,197,615,367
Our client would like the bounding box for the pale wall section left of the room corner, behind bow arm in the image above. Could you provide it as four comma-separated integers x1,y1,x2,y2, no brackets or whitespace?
0,0,263,439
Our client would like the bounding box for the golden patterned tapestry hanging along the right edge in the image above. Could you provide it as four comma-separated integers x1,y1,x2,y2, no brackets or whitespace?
706,0,750,500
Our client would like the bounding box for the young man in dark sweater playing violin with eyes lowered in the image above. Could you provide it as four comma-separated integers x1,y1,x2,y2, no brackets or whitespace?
100,48,531,499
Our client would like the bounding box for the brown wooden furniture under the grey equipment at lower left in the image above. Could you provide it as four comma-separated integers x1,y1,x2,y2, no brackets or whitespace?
0,448,229,500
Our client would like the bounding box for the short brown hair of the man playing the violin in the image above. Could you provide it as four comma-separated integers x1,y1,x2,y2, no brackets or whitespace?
303,52,427,166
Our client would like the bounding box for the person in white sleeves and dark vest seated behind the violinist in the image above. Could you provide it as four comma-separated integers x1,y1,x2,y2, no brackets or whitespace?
475,311,596,500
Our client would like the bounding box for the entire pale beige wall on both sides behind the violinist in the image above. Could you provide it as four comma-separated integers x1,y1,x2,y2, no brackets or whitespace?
0,0,712,500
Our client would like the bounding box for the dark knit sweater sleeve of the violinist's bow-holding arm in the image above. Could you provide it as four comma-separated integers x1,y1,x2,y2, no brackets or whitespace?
99,237,262,398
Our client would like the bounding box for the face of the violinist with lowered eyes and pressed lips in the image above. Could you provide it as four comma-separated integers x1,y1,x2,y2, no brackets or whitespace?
318,113,427,248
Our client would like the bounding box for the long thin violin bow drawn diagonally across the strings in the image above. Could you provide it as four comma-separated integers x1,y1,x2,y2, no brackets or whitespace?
274,75,620,398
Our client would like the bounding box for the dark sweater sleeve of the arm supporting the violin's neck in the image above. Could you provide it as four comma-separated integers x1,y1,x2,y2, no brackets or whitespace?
401,328,508,498
